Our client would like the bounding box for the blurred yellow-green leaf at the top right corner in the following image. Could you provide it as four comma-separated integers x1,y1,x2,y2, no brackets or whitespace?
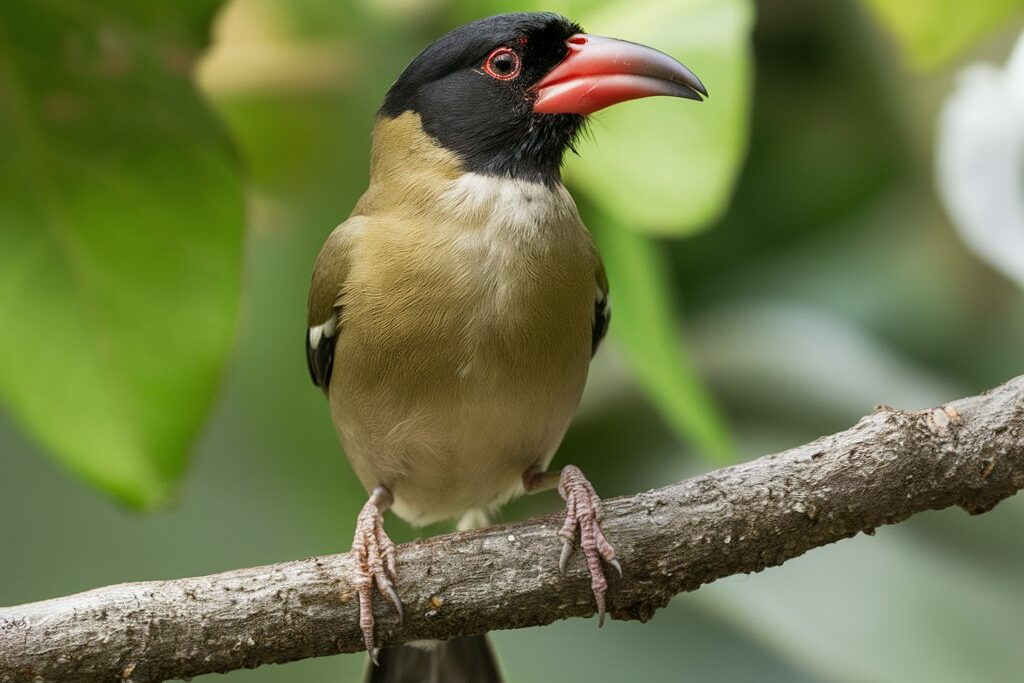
866,0,1024,69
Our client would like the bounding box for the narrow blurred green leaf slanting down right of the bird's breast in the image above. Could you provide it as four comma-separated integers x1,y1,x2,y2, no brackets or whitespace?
588,211,733,465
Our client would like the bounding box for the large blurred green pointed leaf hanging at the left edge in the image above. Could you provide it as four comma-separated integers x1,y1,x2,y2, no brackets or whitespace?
0,0,244,507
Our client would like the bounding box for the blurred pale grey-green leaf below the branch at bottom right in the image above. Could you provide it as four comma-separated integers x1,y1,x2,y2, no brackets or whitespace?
700,507,1024,683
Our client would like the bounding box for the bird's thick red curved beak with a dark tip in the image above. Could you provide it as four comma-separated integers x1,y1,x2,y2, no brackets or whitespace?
531,33,708,116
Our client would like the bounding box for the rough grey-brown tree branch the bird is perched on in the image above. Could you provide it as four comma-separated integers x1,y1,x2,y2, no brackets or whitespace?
0,376,1024,683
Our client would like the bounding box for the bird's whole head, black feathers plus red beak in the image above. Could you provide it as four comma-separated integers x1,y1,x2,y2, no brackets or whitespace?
380,12,708,183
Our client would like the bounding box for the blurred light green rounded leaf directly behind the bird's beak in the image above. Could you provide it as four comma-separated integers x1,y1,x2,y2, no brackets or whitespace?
566,0,754,234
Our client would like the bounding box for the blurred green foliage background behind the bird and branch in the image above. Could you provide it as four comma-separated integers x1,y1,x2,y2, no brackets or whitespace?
0,0,1024,683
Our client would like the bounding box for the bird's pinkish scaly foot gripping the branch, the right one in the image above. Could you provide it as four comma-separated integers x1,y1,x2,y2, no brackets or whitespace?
558,465,623,627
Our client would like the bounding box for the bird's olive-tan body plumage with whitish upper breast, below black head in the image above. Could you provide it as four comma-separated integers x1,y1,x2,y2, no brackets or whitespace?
308,113,607,524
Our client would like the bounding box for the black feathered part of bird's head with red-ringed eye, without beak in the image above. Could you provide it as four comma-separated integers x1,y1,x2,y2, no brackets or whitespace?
380,12,584,183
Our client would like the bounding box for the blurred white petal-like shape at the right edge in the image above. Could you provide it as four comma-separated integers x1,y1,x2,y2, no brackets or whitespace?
935,29,1024,285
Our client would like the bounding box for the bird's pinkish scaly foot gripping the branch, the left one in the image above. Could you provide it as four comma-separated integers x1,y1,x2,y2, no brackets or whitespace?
352,486,404,665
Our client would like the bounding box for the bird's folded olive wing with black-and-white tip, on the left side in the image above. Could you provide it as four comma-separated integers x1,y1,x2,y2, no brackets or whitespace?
305,216,364,392
